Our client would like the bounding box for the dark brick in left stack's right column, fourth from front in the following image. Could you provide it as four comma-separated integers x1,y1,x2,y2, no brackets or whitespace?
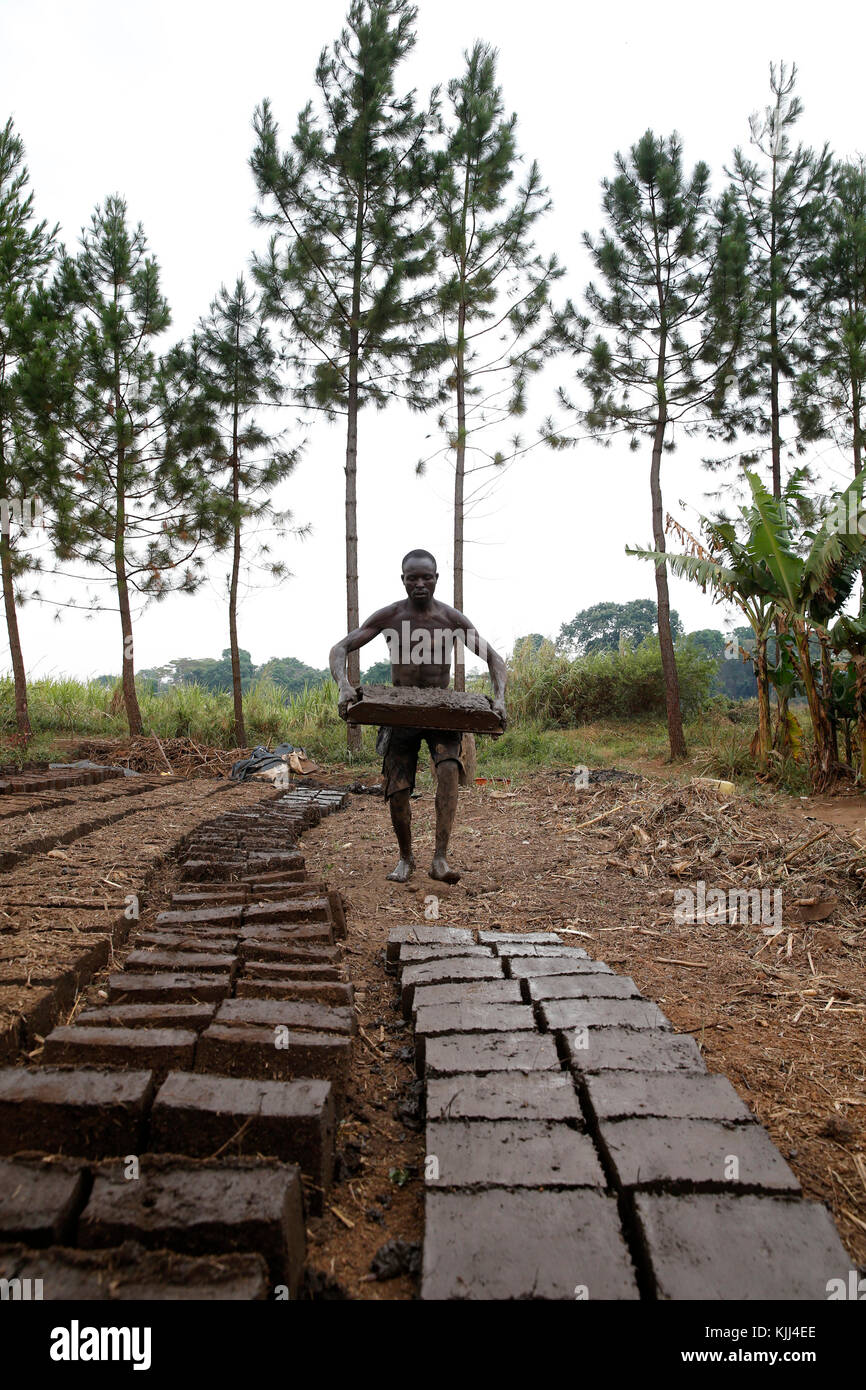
196,1023,352,1091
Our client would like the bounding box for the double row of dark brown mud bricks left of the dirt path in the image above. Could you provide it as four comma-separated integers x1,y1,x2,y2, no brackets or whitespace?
0,788,354,1300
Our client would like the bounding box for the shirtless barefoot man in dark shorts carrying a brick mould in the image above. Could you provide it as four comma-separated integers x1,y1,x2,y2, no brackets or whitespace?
328,550,506,883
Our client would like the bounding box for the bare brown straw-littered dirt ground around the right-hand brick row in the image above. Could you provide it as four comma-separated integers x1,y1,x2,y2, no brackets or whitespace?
303,773,866,1298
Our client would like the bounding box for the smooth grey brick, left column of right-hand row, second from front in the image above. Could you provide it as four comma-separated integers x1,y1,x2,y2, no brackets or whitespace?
425,1120,607,1188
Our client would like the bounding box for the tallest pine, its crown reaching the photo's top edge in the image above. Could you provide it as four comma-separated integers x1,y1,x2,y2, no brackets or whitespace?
250,0,434,749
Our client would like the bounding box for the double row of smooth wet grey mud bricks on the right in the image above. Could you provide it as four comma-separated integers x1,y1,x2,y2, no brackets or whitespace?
386,927,851,1300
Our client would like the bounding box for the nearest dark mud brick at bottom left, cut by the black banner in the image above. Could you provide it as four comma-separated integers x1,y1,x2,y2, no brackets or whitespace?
0,1241,271,1302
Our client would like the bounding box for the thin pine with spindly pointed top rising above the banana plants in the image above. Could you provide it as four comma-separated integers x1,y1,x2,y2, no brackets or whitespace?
728,63,831,498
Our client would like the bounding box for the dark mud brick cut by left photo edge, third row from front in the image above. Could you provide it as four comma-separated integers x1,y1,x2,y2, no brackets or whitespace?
0,1068,153,1158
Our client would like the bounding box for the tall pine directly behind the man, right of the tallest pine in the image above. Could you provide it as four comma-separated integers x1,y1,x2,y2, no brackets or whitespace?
418,43,563,717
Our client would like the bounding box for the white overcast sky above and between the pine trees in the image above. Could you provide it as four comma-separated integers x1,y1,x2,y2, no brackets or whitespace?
0,0,866,676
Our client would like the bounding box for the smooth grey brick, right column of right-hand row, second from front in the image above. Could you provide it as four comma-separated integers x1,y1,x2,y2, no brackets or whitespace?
600,1101,799,1193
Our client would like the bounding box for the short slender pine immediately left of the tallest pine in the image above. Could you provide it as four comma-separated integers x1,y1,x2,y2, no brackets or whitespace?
177,277,306,748
